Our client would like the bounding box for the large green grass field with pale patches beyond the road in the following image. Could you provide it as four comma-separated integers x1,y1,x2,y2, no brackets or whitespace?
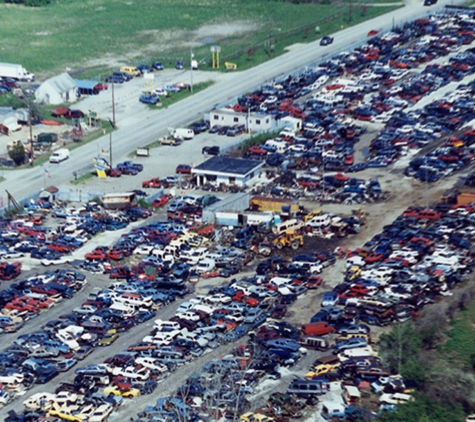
0,0,399,79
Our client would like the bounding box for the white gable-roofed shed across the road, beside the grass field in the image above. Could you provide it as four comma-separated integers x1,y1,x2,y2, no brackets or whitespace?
35,73,78,104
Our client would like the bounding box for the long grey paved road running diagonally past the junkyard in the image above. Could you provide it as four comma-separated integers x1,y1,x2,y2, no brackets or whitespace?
0,0,468,204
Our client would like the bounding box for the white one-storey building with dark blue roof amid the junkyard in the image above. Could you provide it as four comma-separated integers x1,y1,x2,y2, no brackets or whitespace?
191,156,264,186
